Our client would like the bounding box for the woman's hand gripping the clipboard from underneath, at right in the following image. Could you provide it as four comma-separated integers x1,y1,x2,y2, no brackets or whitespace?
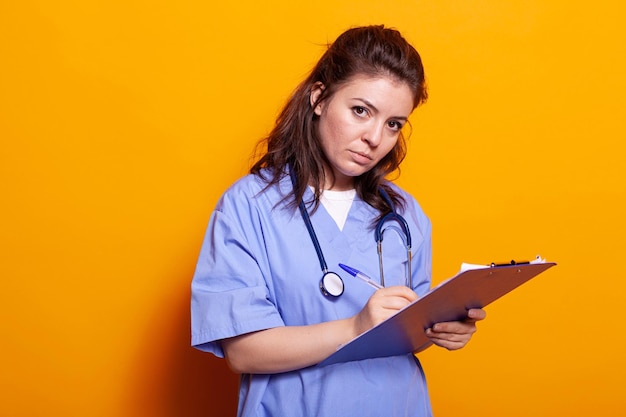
426,308,487,350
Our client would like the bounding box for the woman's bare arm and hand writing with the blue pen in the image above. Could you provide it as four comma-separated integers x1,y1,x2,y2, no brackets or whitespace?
221,286,417,373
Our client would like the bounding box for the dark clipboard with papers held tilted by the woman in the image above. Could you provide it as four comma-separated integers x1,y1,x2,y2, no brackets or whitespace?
318,262,556,366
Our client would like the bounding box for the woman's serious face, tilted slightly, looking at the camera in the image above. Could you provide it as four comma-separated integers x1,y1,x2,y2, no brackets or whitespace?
311,75,413,190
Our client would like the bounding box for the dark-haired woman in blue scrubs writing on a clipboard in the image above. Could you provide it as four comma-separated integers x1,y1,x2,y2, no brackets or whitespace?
191,26,485,417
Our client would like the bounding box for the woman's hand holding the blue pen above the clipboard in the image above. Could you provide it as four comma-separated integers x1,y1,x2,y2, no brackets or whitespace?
354,285,417,335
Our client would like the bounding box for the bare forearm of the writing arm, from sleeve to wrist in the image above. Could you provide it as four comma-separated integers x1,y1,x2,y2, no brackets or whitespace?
222,318,357,374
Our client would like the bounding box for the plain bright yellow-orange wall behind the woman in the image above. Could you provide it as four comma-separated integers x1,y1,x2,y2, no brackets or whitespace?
0,0,626,417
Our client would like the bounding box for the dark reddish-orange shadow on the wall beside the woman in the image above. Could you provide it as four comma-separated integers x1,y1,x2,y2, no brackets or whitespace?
129,286,239,417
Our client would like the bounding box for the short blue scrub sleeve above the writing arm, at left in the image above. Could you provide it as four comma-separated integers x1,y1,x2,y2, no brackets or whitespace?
191,206,284,357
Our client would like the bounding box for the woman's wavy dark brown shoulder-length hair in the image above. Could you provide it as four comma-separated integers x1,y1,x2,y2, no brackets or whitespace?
250,25,427,216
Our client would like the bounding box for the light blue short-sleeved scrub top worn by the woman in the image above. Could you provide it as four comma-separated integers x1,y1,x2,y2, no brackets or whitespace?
191,170,432,417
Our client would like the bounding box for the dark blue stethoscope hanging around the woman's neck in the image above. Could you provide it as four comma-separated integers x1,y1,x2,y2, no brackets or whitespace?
290,169,413,298
